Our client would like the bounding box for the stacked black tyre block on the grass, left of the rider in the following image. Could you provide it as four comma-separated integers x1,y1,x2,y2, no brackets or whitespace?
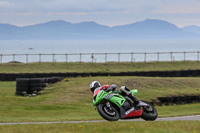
15,77,63,96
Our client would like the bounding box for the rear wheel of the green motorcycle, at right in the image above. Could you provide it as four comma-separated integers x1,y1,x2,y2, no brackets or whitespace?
141,101,158,121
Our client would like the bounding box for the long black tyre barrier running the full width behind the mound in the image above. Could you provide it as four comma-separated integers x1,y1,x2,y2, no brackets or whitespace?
0,69,200,81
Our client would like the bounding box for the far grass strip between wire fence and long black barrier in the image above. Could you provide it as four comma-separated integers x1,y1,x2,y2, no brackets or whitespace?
0,61,200,73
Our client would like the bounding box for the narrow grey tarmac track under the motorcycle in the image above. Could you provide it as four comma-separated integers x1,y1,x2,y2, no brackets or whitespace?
0,115,200,125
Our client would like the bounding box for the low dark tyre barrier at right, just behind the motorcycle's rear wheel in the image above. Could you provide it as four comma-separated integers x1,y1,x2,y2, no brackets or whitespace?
157,95,200,105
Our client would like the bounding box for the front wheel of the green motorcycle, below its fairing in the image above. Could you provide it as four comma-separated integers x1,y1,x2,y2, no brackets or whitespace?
97,104,119,121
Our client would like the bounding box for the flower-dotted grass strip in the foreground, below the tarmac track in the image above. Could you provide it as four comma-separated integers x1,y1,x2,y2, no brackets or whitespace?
0,121,200,133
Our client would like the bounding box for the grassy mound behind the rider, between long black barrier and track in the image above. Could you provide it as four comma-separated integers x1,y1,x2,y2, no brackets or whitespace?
0,76,200,122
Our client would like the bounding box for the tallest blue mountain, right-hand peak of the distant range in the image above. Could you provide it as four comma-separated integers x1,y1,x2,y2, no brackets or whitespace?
113,19,193,38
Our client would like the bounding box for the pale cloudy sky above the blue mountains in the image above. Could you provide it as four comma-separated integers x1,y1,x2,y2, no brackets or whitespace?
0,0,200,27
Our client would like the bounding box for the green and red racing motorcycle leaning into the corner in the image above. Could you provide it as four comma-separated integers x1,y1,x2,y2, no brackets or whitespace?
93,89,158,121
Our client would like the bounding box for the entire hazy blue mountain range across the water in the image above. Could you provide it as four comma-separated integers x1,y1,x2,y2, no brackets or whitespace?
0,19,200,40
